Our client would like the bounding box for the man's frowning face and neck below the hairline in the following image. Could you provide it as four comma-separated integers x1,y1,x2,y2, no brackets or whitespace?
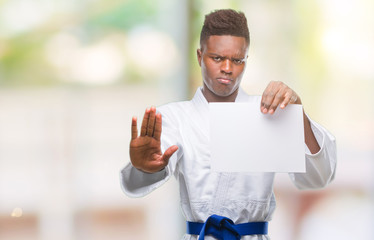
197,35,248,102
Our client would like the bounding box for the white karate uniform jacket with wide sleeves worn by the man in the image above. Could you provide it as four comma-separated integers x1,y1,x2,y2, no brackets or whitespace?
120,88,336,240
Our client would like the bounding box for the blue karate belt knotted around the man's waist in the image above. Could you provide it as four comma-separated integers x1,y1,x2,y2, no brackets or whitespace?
187,215,268,240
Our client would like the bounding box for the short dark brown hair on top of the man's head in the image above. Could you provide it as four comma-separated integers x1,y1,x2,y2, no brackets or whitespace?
200,9,249,47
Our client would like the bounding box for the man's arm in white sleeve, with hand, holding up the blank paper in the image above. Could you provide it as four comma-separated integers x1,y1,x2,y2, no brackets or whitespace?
261,82,336,189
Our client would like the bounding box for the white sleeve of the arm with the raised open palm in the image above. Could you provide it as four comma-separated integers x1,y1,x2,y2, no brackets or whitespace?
120,107,183,197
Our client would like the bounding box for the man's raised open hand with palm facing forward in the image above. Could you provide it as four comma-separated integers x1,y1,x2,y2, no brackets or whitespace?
130,107,178,173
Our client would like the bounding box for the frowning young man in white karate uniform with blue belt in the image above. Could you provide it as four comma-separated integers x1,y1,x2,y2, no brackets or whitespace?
121,10,336,240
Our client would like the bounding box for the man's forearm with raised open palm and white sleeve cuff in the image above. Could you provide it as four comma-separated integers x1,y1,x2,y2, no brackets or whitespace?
120,107,178,197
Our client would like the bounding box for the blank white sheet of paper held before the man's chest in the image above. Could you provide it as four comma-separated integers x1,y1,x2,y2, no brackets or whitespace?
209,102,305,172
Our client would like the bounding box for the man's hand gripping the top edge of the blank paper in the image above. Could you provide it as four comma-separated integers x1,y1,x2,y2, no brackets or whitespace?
261,82,301,114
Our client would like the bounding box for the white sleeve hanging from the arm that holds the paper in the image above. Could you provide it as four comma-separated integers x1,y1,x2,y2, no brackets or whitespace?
289,119,337,189
